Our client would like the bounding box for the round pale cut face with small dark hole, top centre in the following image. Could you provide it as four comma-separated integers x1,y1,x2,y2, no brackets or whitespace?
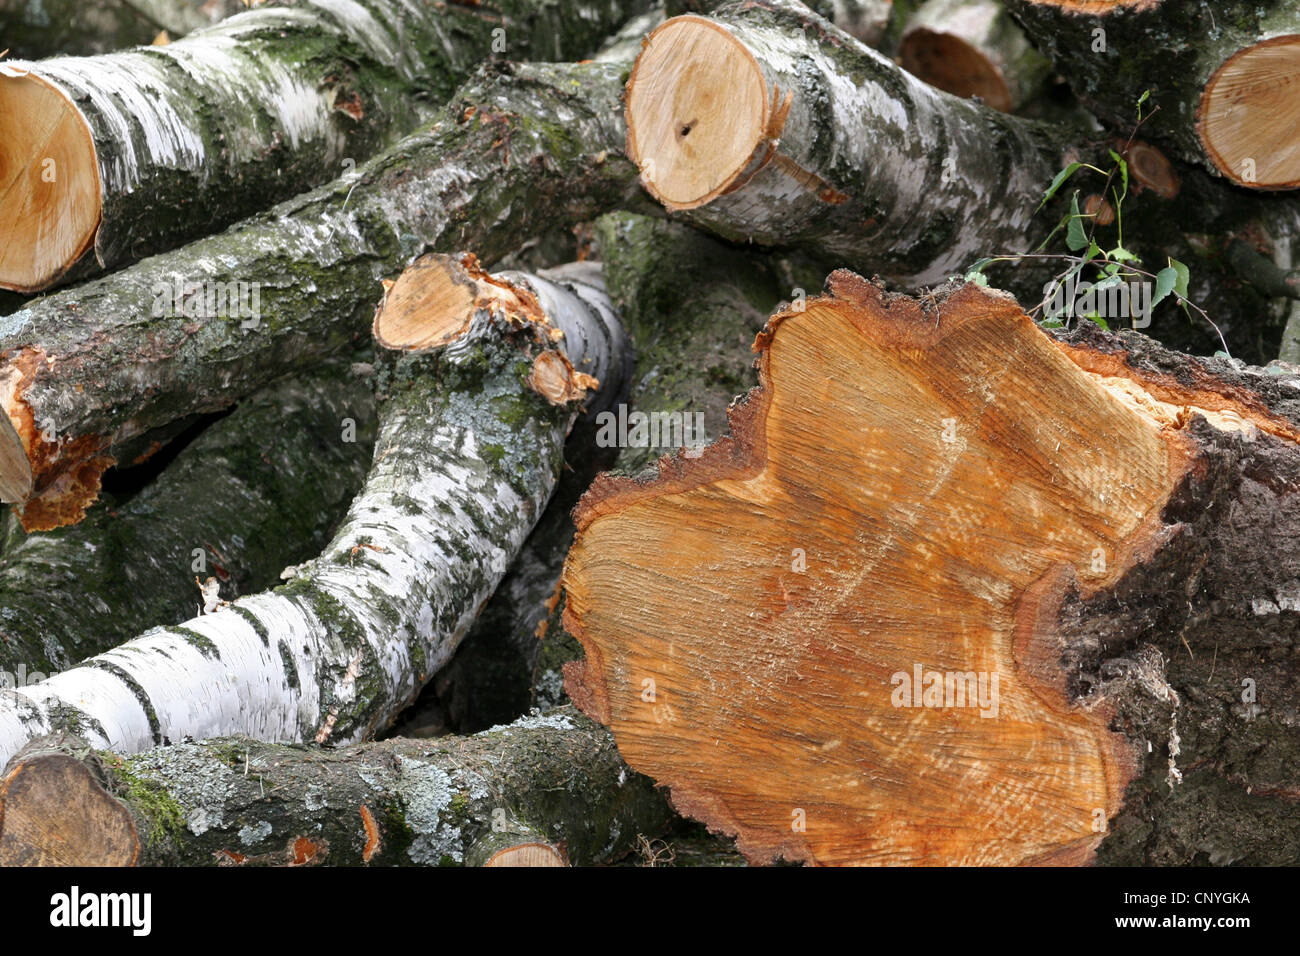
627,14,771,209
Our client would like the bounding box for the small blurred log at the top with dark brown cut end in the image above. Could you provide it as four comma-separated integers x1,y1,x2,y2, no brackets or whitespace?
899,0,1052,113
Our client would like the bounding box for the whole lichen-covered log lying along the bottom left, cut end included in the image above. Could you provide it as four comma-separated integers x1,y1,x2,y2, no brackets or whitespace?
0,709,672,866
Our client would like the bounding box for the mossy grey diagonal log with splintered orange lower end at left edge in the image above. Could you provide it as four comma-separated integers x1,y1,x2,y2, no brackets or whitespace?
0,64,637,528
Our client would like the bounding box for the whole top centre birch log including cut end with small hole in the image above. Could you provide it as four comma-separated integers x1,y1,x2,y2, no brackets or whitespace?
627,0,1086,285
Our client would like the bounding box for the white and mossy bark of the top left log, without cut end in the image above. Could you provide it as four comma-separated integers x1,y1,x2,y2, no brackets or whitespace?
15,0,649,287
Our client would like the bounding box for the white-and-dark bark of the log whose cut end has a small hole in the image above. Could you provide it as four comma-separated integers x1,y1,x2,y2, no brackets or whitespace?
628,0,1063,286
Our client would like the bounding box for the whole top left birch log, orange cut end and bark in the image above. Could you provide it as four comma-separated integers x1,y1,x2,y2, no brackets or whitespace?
0,0,644,290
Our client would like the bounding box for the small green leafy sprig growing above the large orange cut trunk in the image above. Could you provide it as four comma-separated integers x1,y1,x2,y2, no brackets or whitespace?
965,91,1227,355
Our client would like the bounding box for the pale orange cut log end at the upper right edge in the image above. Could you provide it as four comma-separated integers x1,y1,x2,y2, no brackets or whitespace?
1196,34,1300,189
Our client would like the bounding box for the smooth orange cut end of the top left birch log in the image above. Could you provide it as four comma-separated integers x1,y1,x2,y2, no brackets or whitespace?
0,68,101,293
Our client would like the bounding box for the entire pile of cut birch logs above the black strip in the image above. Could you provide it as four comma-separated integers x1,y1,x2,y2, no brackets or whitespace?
0,0,1300,866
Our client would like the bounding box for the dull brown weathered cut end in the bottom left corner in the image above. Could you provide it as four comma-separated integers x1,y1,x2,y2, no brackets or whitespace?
0,752,140,866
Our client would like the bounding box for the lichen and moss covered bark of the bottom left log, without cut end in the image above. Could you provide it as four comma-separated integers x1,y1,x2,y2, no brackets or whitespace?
83,709,671,866
